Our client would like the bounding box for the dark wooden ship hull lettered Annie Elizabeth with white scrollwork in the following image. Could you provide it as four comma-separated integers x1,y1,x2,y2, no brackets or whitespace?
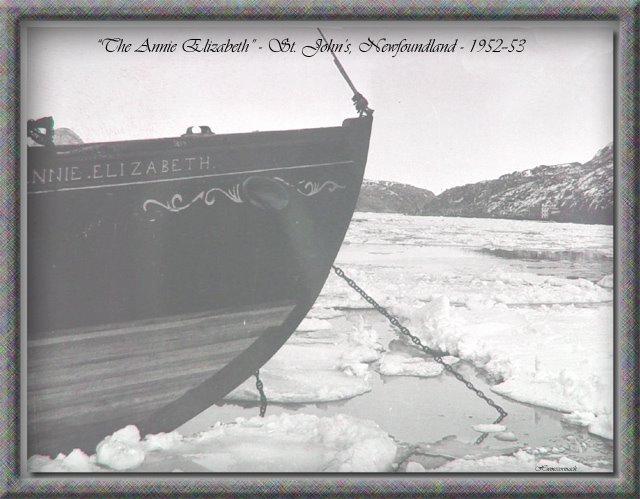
27,116,372,455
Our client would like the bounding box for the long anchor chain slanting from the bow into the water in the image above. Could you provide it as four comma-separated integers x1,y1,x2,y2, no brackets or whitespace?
332,265,508,444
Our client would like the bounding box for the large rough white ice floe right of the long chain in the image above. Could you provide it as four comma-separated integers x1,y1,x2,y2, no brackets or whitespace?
382,296,613,436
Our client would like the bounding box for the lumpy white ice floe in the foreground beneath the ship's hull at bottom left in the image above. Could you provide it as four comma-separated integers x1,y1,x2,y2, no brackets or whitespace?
28,414,397,473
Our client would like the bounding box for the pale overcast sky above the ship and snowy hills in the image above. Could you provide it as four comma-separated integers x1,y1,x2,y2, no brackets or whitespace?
22,21,614,194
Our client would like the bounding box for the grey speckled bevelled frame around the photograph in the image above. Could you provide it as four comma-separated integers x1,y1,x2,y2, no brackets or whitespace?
0,0,640,497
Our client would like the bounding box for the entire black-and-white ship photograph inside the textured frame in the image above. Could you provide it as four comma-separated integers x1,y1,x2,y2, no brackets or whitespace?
20,20,616,472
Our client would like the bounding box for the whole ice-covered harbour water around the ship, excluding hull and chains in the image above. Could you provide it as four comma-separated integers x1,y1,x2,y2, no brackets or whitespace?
28,213,614,473
